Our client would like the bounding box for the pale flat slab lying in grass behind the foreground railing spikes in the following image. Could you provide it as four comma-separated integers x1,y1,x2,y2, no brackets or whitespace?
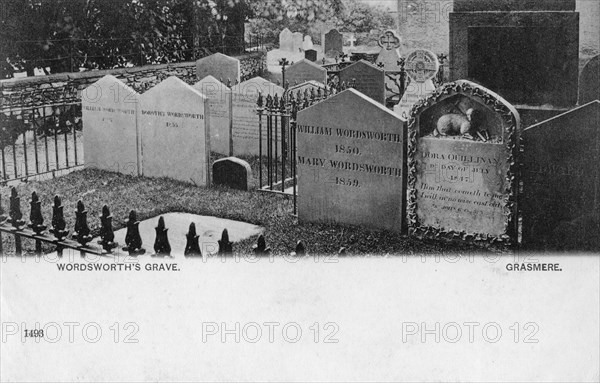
92,213,264,258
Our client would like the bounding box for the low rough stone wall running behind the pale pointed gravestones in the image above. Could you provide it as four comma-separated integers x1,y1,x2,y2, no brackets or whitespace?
0,52,267,110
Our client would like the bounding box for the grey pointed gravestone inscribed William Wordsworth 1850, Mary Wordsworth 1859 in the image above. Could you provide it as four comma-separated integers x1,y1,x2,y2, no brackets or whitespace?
297,89,406,232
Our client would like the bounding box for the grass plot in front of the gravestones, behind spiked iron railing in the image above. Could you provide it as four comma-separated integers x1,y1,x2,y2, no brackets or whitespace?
0,169,506,255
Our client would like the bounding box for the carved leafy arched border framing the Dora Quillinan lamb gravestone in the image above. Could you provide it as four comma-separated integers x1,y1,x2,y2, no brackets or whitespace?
407,81,520,245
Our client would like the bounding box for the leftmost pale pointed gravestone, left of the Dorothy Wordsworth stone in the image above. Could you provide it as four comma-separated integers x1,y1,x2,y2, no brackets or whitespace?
81,75,140,175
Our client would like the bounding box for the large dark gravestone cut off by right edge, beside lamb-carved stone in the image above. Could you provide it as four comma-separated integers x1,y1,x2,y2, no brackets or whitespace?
519,100,600,252
